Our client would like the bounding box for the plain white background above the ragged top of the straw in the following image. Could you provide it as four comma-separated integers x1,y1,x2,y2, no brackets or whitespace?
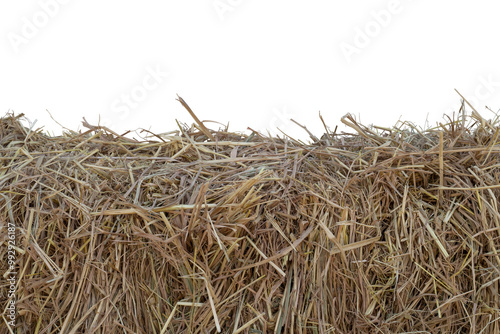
0,0,500,139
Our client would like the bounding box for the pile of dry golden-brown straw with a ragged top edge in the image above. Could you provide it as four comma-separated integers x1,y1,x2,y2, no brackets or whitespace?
0,102,500,334
